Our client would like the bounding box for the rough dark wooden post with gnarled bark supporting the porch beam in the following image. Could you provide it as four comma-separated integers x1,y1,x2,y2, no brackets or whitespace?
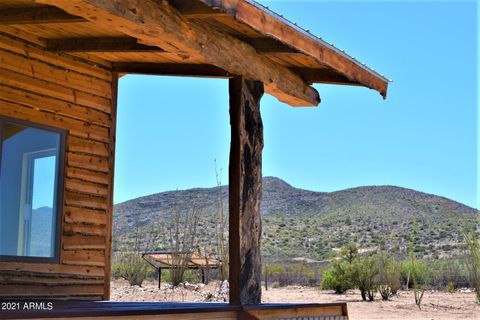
229,77,264,305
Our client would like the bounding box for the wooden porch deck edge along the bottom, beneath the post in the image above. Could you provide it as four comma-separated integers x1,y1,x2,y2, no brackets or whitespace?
0,301,348,320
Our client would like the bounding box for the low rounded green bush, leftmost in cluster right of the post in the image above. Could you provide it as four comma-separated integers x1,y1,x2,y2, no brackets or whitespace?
320,261,354,294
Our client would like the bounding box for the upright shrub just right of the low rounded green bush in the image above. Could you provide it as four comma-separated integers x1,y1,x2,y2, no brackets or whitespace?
351,256,379,301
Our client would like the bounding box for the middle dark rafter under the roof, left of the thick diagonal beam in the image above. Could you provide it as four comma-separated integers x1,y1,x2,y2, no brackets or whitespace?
47,37,165,52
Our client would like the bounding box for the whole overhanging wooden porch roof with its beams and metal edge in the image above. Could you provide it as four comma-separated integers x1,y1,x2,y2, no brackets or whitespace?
0,0,389,106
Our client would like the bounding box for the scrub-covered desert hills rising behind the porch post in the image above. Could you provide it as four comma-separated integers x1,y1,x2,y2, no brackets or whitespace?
114,177,478,261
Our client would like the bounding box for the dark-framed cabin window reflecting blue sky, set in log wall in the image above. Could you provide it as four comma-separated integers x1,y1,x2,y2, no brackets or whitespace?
0,117,65,262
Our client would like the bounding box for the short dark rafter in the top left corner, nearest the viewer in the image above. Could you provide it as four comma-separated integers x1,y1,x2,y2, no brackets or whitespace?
0,7,87,25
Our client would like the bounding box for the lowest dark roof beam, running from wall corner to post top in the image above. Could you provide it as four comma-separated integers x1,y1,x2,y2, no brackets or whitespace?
113,62,233,78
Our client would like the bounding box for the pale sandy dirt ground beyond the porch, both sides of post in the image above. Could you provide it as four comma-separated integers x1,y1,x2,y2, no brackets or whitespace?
111,281,480,320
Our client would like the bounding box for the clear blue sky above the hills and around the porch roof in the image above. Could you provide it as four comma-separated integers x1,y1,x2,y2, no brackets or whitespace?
115,1,480,207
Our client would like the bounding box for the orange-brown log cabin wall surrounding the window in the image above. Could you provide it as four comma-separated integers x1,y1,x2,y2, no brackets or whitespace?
0,26,117,300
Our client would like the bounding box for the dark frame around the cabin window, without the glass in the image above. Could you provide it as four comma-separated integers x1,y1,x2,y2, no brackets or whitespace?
0,115,68,264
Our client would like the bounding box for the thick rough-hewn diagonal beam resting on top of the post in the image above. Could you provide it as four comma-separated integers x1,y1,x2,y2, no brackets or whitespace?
36,0,320,106
